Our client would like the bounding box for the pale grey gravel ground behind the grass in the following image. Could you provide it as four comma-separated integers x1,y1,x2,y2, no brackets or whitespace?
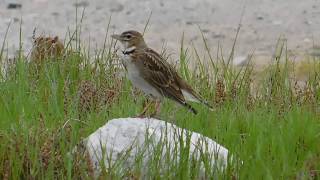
0,0,320,63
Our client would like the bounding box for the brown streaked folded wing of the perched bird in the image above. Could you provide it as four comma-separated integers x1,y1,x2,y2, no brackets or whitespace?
131,48,186,105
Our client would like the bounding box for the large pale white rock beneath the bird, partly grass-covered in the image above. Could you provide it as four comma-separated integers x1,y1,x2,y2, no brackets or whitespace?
76,118,228,176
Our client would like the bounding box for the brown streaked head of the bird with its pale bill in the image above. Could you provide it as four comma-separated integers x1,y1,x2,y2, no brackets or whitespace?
111,30,147,49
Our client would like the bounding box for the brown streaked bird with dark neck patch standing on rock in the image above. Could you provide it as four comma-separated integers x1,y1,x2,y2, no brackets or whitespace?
111,30,212,114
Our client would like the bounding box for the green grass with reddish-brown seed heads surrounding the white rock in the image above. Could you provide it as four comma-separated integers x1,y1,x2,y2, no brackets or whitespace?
0,23,320,179
